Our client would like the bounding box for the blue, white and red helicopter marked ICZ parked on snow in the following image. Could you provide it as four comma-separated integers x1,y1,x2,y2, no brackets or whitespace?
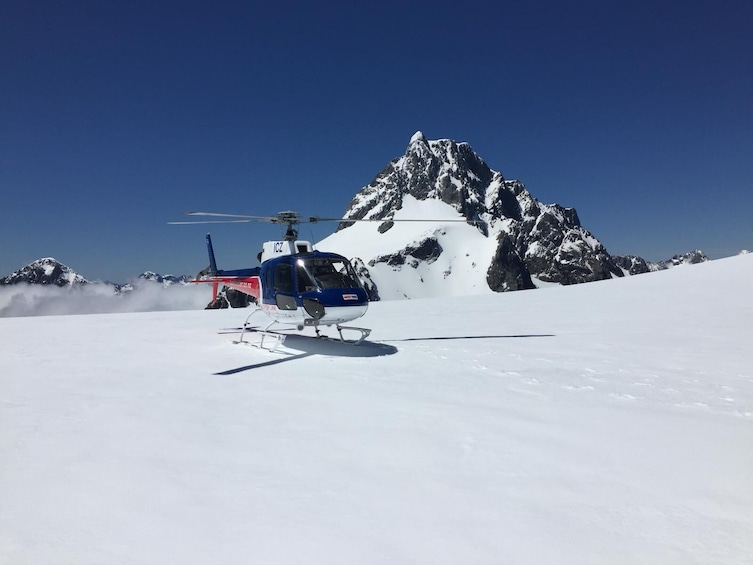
168,210,476,351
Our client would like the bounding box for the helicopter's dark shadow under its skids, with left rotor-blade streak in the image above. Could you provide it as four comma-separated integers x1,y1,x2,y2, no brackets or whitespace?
214,333,397,375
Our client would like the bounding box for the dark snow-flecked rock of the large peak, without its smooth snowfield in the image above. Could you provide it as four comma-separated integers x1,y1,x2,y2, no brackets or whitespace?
328,131,625,291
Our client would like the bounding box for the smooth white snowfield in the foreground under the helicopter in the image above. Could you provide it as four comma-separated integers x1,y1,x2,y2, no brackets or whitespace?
0,255,753,564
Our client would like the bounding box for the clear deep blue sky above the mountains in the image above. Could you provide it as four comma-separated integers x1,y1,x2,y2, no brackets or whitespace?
0,0,753,282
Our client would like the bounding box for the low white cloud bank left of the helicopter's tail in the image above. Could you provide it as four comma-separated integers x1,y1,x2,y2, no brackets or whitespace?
0,281,211,317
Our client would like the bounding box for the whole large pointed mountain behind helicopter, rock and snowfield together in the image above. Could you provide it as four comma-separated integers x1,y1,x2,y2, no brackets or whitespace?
318,132,704,298
